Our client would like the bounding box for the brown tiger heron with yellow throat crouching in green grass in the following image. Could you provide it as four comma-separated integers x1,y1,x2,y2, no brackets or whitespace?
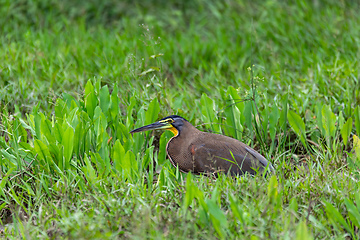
130,115,274,175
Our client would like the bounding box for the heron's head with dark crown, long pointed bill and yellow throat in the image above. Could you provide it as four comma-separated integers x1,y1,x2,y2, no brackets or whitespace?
130,115,187,136
